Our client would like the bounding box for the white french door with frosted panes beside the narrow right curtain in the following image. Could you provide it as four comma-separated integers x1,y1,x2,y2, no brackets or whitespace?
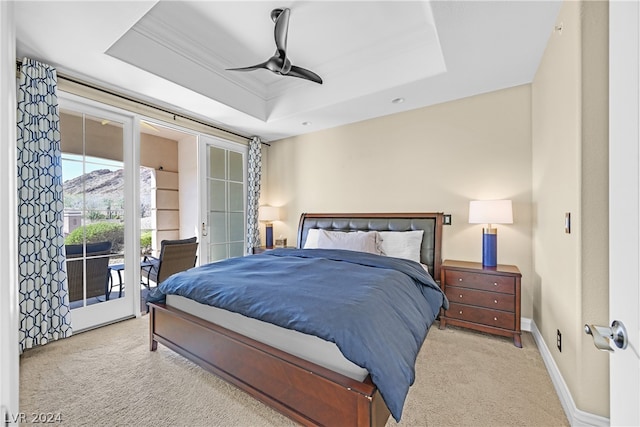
200,135,247,263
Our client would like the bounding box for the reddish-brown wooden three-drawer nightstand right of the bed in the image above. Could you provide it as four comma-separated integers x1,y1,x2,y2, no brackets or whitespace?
440,260,522,348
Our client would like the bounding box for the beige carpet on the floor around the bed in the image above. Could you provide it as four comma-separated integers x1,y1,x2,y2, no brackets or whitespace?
20,316,569,427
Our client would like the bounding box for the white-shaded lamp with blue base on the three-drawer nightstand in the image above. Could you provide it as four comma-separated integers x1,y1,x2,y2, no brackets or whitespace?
469,200,513,267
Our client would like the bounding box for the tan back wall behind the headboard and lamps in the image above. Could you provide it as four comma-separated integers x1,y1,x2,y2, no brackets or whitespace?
262,85,533,317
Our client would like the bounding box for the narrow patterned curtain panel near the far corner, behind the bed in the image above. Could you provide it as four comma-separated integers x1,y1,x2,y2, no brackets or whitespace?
247,136,262,253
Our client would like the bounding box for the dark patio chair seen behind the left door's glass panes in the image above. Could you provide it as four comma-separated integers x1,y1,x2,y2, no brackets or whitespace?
65,242,111,302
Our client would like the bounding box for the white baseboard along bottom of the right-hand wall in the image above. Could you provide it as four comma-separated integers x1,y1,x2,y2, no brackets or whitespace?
520,318,610,427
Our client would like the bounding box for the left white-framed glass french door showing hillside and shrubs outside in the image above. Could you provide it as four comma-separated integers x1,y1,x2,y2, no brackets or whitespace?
60,96,140,332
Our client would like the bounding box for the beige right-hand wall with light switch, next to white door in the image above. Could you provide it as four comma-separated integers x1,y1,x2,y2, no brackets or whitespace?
532,2,609,416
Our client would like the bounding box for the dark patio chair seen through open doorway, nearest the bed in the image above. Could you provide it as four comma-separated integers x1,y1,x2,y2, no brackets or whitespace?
140,237,198,288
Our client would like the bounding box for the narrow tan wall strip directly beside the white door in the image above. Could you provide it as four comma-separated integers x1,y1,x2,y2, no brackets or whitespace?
574,1,610,416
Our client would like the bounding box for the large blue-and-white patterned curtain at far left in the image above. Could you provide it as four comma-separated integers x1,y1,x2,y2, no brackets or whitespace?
17,58,72,351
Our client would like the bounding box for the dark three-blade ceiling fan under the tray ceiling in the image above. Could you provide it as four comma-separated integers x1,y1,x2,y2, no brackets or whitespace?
228,8,322,84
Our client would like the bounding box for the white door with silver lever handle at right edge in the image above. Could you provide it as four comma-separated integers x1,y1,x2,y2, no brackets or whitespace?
607,0,640,426
